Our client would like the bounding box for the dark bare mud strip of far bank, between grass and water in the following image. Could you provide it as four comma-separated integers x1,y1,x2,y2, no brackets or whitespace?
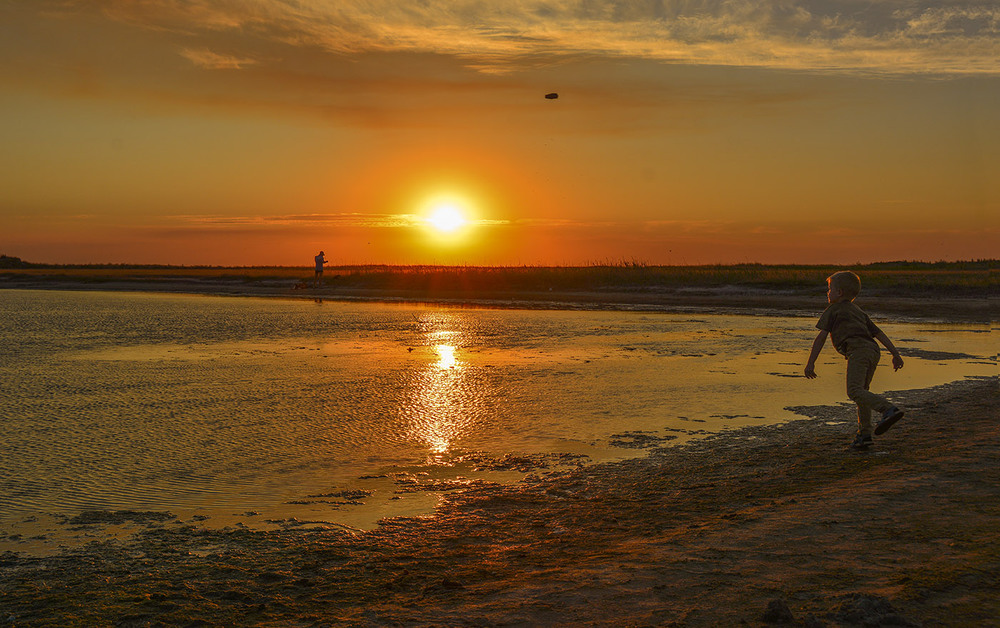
0,274,994,325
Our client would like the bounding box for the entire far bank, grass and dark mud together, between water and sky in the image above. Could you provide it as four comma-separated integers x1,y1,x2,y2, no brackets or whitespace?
0,258,1000,323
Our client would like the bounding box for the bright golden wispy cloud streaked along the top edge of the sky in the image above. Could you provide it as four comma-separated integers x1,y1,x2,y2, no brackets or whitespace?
79,0,1000,75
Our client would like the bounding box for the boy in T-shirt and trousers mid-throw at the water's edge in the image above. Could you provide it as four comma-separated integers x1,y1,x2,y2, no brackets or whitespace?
805,270,903,449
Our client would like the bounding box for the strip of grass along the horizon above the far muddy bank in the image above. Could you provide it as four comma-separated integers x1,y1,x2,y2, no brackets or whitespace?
0,260,998,297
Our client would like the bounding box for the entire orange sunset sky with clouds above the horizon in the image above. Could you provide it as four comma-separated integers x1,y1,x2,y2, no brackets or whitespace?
0,0,1000,266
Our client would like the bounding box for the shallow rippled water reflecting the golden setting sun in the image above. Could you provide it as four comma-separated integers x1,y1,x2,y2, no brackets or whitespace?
0,290,996,536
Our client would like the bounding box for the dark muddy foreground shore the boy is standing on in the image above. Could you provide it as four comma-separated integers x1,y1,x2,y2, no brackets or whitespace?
0,379,1000,626
